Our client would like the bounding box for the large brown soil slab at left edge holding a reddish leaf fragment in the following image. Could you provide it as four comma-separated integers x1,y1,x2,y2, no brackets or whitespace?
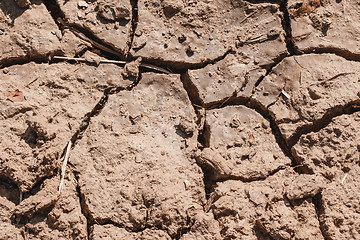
0,63,131,192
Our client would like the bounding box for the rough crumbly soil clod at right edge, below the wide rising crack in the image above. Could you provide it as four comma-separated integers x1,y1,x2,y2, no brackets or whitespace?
292,113,360,179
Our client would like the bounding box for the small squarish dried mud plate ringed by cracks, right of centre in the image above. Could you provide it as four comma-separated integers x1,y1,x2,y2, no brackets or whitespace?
197,106,291,181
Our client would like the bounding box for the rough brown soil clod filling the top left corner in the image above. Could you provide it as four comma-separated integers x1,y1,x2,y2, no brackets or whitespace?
0,0,61,64
